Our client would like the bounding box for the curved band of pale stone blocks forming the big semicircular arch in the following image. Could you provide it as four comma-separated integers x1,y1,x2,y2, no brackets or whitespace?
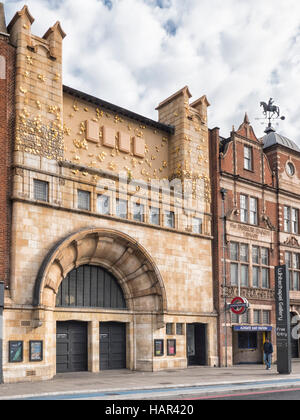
34,229,167,314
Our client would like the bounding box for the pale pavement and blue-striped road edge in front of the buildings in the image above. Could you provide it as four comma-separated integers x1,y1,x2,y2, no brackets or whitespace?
0,362,300,400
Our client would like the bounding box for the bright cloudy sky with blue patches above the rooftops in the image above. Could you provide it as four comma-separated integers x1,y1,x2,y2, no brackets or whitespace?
2,0,300,144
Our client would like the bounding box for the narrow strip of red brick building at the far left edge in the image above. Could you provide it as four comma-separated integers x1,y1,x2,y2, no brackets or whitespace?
0,3,15,284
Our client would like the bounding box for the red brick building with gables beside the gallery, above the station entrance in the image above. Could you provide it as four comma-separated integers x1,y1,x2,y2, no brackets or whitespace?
210,115,300,366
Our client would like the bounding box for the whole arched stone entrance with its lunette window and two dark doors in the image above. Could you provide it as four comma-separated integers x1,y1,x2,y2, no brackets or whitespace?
34,229,167,372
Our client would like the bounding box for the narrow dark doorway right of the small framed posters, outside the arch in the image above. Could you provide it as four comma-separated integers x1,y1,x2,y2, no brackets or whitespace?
187,324,206,366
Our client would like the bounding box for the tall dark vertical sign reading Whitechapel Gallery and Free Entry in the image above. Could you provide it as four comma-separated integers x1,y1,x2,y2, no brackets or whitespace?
275,265,292,374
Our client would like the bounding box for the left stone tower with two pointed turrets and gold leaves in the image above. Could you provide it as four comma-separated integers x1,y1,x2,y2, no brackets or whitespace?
8,6,65,160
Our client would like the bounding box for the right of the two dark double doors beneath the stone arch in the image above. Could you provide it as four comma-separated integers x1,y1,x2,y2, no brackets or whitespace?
100,322,126,370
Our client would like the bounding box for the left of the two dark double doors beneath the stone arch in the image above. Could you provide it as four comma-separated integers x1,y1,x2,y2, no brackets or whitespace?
56,321,88,373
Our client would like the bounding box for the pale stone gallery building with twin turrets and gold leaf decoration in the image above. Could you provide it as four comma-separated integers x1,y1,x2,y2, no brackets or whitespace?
3,6,218,382
